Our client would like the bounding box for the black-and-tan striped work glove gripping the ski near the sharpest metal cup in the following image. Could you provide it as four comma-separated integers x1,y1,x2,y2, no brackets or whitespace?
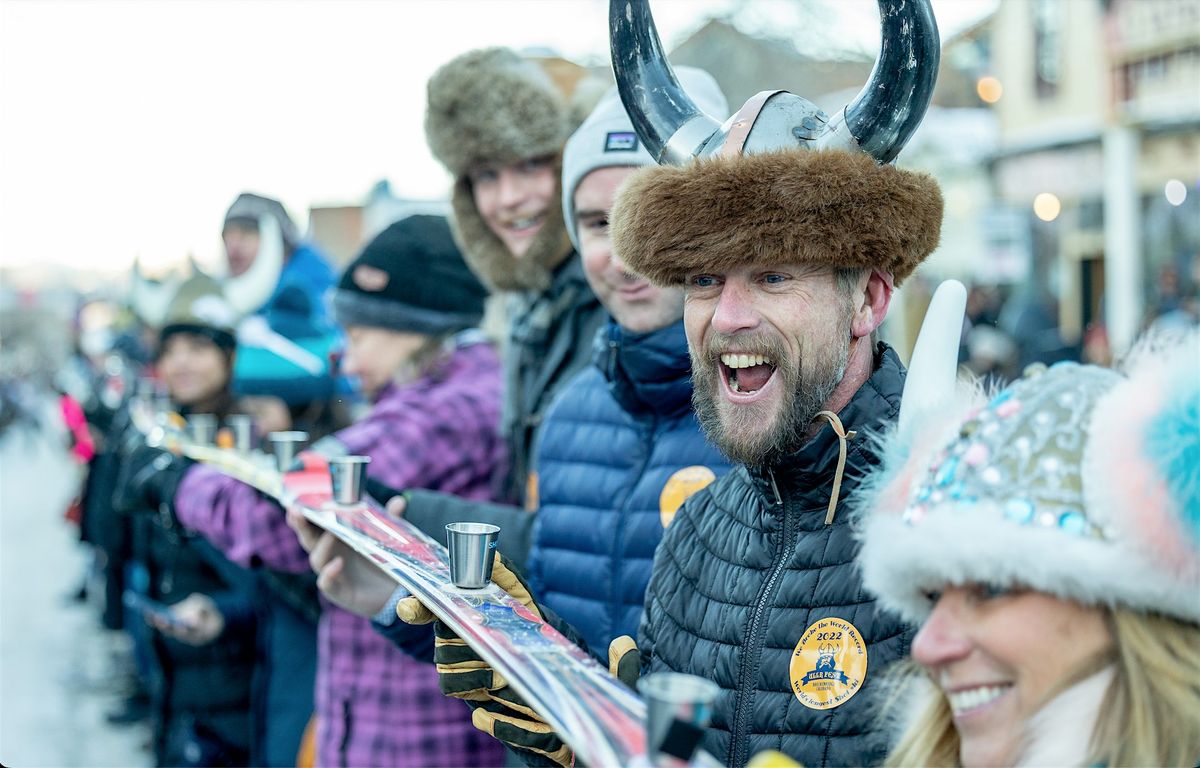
396,554,575,768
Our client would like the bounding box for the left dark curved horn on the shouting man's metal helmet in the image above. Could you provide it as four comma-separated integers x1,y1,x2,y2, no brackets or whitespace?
608,0,720,166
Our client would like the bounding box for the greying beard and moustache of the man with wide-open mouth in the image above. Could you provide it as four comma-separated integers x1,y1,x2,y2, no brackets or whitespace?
691,333,850,467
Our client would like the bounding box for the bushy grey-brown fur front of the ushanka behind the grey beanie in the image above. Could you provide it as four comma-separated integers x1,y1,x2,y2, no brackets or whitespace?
425,48,571,176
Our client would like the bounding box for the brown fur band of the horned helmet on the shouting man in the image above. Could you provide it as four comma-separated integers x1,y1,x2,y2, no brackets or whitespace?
610,149,942,286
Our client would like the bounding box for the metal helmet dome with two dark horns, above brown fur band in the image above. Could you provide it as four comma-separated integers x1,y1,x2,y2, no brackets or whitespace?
608,0,941,166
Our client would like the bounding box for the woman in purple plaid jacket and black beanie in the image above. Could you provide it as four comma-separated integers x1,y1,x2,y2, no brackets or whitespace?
174,216,504,766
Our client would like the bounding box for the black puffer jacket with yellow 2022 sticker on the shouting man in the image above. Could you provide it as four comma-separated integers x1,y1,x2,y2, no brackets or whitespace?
638,344,912,767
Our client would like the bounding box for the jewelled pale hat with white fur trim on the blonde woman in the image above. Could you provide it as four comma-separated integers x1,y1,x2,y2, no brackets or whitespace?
857,332,1200,623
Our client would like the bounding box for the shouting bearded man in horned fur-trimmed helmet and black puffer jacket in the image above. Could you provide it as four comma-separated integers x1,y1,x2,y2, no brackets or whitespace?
610,0,942,766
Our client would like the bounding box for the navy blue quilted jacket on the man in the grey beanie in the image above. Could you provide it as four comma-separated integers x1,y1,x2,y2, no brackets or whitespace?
528,322,728,660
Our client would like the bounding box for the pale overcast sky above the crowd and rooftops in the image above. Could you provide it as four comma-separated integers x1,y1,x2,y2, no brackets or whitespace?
0,0,996,276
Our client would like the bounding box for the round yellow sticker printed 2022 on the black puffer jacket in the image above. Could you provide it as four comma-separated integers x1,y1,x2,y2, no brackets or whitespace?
788,616,866,709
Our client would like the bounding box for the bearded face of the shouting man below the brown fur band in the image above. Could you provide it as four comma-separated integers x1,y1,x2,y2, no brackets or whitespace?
686,263,864,466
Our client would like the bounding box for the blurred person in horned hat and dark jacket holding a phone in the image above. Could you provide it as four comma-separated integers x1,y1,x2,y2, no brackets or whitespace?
107,274,256,766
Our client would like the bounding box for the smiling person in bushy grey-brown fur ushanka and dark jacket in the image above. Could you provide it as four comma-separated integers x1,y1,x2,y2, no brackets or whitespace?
384,48,605,547
